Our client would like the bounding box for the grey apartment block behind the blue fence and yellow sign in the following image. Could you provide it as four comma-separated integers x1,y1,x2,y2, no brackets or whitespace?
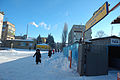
68,25,92,45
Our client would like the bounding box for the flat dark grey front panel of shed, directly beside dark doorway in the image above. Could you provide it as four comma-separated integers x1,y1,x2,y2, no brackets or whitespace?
85,45,108,75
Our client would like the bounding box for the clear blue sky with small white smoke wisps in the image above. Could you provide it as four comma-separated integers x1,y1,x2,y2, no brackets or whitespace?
0,0,120,42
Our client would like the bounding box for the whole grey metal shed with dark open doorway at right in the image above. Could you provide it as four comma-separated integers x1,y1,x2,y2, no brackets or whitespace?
78,36,120,76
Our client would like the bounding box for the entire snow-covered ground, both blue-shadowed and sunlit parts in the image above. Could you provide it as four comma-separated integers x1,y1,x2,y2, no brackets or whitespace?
0,49,118,80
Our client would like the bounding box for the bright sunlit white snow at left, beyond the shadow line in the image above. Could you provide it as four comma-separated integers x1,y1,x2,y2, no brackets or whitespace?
0,49,47,63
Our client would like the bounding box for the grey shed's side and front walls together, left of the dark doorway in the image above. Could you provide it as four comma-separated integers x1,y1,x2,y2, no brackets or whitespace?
77,44,108,76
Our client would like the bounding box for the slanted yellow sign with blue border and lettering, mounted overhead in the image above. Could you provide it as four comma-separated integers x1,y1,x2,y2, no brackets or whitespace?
85,2,108,31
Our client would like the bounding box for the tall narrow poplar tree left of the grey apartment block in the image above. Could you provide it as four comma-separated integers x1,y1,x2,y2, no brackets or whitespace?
62,23,68,48
